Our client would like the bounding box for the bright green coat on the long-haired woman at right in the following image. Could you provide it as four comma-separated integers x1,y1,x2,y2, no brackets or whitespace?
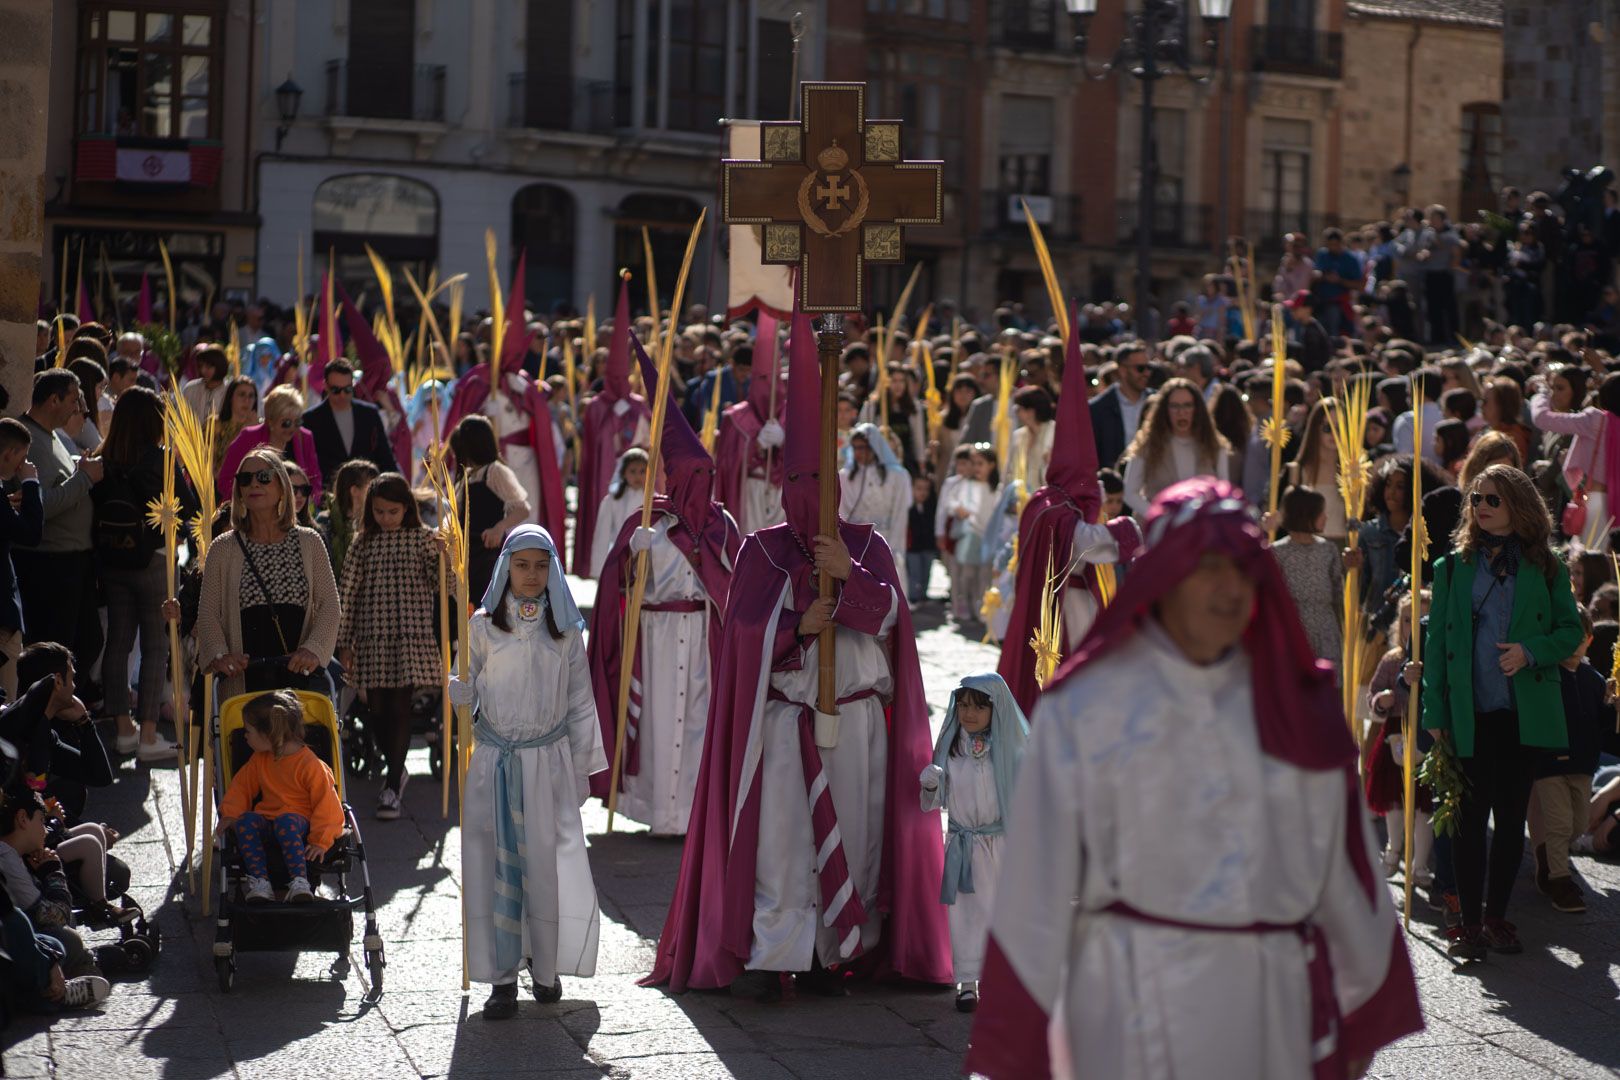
1422,552,1584,758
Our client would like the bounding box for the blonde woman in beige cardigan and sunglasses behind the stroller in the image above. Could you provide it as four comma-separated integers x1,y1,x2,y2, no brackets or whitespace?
196,450,339,698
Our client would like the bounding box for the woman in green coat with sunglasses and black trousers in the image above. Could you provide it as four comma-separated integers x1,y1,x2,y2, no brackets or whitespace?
1422,465,1584,960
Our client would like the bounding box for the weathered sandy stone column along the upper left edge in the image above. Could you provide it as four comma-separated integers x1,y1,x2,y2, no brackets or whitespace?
0,0,50,413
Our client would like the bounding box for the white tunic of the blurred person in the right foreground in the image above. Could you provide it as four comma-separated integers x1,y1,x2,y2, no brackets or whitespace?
993,622,1395,1080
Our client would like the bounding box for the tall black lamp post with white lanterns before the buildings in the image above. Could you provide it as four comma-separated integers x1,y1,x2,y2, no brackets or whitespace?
1064,0,1233,338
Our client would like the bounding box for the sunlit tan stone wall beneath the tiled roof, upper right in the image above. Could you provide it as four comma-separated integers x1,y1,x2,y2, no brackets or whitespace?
1340,18,1502,225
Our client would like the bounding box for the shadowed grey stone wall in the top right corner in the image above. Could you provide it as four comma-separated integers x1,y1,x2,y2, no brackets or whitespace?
1502,0,1620,191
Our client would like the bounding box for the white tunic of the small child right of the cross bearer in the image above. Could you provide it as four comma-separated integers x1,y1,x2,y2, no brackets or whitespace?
922,732,1006,983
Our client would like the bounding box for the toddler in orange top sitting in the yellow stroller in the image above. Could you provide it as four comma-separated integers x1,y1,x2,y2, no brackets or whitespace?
219,690,343,902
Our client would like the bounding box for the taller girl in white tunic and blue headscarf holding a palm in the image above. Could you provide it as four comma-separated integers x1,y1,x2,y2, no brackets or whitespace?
450,525,608,1020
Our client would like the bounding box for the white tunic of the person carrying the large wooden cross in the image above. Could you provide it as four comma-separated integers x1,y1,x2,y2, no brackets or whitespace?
748,579,910,972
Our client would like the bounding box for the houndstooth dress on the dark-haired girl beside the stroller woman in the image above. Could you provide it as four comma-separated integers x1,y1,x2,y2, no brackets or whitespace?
337,528,442,690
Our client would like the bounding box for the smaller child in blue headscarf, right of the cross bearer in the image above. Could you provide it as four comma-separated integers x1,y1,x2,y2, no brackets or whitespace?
919,674,1029,1012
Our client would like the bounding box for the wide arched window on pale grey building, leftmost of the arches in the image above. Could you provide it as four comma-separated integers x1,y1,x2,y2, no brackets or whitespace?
311,173,439,295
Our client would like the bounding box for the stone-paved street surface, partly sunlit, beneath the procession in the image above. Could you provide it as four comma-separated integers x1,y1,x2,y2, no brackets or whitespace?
3,569,1620,1080
